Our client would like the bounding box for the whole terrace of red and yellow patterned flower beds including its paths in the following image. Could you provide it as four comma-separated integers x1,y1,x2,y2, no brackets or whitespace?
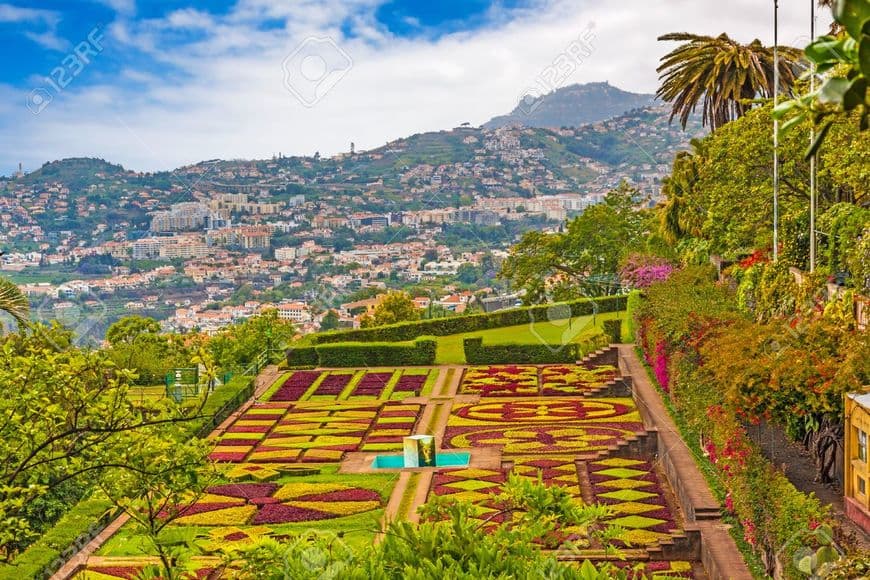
70,350,748,578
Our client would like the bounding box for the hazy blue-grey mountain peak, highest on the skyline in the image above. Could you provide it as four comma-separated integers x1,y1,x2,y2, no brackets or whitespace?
483,82,655,129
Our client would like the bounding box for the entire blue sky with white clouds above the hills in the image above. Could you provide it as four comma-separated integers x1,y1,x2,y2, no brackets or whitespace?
0,0,830,175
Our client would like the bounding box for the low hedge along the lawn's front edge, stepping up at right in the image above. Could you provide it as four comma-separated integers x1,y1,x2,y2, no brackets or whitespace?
462,334,606,365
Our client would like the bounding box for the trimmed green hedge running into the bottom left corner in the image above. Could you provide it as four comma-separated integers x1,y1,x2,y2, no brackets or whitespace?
0,497,118,580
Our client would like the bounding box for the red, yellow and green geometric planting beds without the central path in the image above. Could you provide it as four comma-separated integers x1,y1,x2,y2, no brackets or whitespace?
88,365,693,580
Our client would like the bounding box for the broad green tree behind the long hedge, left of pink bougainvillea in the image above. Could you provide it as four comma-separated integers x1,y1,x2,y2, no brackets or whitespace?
499,183,649,303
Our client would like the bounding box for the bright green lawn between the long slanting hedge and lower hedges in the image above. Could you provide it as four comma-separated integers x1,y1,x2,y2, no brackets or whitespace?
435,311,625,364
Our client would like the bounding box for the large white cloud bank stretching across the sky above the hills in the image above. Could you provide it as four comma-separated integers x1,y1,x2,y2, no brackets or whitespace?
0,0,826,172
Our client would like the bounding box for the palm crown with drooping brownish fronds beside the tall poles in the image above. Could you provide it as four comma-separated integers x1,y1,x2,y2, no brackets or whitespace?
656,32,803,129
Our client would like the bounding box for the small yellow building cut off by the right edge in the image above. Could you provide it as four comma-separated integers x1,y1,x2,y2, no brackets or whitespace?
843,391,870,533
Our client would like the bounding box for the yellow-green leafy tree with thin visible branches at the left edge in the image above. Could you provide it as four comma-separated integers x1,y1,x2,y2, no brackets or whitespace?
0,324,201,559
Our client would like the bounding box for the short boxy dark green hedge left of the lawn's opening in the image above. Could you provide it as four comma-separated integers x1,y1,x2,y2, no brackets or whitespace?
314,339,438,367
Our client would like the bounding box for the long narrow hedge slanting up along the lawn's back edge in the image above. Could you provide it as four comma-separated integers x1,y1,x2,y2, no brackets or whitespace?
314,296,626,344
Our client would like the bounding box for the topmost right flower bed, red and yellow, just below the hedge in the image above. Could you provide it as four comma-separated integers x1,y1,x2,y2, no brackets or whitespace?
459,364,619,397
